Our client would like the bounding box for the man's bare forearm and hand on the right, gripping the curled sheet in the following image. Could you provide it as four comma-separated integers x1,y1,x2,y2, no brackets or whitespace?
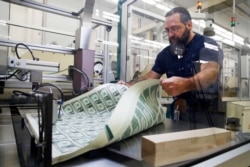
161,61,220,96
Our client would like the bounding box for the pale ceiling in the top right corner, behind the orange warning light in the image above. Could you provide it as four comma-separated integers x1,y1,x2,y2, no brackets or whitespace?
176,0,250,41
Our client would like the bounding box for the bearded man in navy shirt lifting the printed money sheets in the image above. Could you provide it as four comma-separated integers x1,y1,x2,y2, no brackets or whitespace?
119,7,223,125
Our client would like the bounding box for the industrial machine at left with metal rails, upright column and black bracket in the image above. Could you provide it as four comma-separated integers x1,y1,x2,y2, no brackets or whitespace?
0,0,112,166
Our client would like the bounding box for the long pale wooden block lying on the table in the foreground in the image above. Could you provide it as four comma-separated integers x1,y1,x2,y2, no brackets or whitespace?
141,128,231,166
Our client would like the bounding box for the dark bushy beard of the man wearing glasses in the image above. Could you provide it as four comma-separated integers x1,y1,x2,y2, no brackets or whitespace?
169,28,190,55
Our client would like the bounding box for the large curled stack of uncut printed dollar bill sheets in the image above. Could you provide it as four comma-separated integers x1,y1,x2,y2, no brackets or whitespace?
26,80,166,164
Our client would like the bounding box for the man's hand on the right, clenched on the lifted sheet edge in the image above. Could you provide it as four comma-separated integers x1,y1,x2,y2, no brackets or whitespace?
160,77,190,96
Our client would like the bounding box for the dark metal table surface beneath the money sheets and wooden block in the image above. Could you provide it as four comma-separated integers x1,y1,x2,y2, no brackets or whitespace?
12,106,250,167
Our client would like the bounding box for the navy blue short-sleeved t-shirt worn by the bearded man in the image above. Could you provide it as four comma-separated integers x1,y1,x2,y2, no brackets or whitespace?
152,34,223,102
